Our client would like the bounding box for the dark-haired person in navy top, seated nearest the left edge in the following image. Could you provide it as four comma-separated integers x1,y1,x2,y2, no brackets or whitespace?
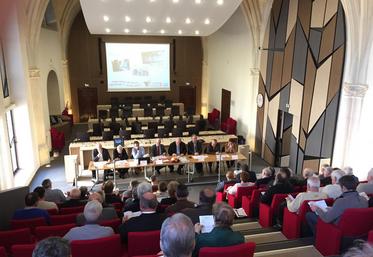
13,192,50,224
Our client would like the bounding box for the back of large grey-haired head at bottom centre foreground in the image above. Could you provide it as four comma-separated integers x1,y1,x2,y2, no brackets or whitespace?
160,213,195,257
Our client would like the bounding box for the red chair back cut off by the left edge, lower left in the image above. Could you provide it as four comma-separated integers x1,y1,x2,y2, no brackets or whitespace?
0,228,33,252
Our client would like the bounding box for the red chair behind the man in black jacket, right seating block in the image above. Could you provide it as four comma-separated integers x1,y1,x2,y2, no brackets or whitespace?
259,194,288,228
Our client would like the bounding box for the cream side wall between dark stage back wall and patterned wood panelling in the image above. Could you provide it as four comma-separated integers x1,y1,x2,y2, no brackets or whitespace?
204,8,258,144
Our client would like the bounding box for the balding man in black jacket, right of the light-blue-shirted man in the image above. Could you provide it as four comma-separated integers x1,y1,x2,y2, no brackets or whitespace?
119,192,164,242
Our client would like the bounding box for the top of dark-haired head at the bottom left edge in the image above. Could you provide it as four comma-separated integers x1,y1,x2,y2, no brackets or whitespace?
32,237,71,257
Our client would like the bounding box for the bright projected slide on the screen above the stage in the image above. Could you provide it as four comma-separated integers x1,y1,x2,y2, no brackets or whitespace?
106,43,170,92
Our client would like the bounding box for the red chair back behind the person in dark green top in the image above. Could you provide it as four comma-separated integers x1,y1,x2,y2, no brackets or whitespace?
198,242,256,257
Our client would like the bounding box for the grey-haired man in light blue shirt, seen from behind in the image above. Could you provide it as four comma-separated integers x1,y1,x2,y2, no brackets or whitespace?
63,200,114,242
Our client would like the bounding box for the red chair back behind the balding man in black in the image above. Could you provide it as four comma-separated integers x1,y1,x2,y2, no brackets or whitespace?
128,230,161,257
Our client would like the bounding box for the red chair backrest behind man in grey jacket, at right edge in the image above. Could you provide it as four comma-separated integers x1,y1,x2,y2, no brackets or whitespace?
338,208,373,236
